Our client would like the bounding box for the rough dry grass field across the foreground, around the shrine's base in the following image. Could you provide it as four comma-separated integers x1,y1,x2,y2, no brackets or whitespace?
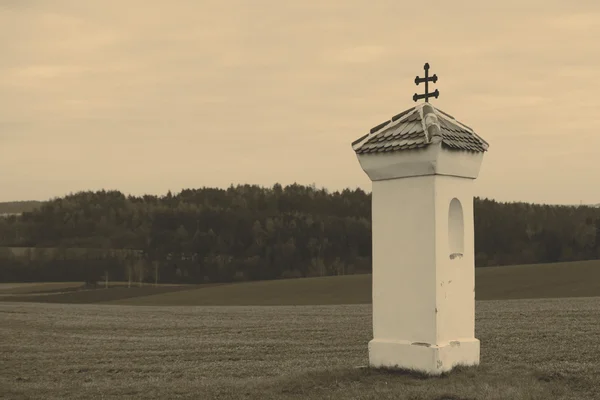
0,298,600,400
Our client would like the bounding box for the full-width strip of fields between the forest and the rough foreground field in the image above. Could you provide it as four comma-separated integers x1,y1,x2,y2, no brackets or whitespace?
0,260,600,306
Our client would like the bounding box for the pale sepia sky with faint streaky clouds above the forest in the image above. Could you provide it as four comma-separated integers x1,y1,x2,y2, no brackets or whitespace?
0,0,600,204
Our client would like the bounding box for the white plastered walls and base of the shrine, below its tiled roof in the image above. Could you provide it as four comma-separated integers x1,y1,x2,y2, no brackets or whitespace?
359,144,482,374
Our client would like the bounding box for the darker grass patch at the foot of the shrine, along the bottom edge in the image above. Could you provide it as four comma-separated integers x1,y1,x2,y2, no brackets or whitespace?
246,366,578,400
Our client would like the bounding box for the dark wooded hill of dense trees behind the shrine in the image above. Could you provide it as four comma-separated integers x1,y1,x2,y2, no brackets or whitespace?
0,184,600,283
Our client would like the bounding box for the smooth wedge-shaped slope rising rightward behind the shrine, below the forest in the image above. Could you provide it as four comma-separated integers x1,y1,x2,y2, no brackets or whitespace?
113,260,600,305
